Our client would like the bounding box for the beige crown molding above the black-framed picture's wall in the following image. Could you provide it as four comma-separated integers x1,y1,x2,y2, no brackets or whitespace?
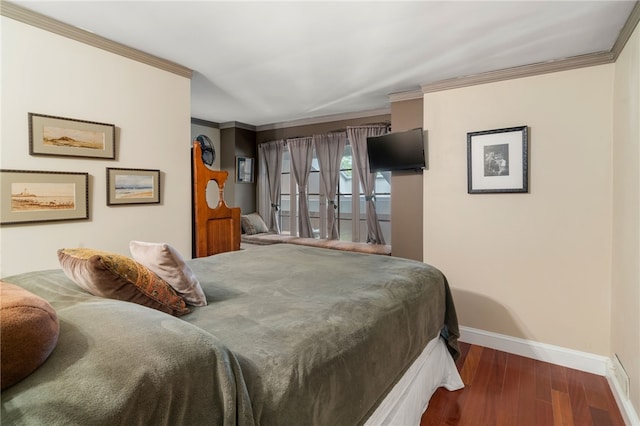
421,52,614,93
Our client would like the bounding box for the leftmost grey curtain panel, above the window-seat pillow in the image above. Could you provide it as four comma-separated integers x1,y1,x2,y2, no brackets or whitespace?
258,139,284,234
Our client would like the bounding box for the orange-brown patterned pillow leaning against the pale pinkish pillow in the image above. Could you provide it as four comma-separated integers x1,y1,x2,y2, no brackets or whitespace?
58,248,189,316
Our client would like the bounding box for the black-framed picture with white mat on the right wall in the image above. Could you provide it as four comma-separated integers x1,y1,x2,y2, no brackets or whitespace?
467,126,529,194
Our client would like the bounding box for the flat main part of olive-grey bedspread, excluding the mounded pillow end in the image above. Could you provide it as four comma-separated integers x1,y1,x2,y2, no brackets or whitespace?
183,244,459,426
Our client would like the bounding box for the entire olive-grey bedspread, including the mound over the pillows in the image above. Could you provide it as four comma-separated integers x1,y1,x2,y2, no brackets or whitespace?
1,244,459,426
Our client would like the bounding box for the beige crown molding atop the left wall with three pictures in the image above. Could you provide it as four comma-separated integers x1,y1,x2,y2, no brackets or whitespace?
0,0,193,79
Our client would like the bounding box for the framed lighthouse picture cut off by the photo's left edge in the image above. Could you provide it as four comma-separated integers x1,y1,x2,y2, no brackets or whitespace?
0,170,89,225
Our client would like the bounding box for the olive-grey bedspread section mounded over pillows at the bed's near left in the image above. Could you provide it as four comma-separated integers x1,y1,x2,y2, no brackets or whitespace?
0,270,254,426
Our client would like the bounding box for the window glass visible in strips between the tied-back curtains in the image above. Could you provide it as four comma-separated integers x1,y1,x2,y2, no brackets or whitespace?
280,143,391,244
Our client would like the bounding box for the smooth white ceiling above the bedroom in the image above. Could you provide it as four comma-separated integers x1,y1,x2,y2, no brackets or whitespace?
7,0,634,126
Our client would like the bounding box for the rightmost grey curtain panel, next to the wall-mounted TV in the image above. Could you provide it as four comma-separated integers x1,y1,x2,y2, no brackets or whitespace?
347,125,388,244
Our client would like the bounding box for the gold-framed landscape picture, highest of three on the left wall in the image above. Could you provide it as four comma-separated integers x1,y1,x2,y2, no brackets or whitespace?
29,113,116,159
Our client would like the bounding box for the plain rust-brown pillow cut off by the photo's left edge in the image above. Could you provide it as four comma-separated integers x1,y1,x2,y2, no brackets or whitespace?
0,281,60,389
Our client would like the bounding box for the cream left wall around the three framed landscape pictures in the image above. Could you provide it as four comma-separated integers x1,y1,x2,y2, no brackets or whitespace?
0,16,191,276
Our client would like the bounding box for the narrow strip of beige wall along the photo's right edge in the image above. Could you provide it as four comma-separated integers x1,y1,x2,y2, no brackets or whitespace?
611,24,640,413
